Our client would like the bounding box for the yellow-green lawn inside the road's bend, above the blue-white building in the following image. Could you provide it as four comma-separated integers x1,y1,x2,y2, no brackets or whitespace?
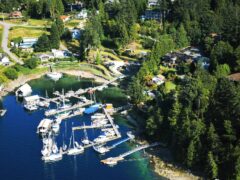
9,27,48,41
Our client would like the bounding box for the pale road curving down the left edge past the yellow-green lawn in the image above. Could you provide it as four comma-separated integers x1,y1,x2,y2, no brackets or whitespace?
0,21,23,64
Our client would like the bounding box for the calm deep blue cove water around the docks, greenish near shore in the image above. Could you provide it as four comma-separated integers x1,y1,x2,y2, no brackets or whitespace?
0,77,160,180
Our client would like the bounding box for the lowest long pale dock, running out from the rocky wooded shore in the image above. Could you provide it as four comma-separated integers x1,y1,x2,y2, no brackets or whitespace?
101,143,160,165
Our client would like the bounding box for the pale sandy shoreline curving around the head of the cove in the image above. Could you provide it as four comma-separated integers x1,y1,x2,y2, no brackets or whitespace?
0,69,108,97
